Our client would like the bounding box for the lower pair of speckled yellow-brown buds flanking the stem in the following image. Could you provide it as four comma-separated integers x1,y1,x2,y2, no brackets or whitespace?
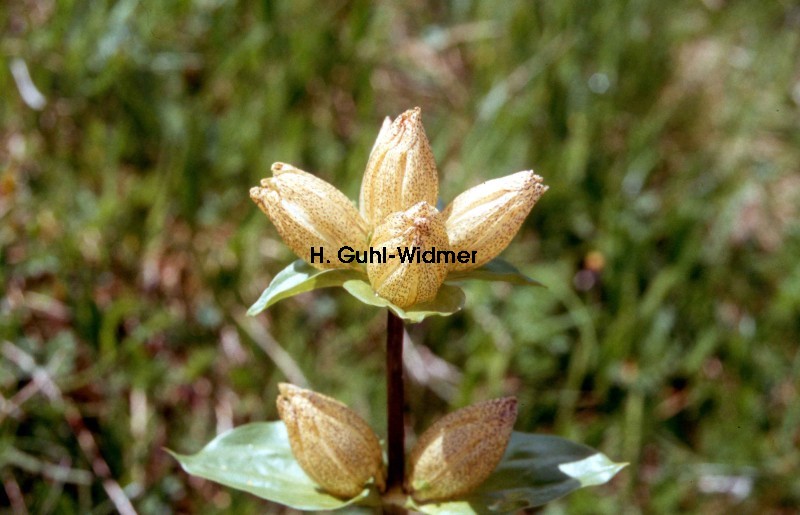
277,383,517,503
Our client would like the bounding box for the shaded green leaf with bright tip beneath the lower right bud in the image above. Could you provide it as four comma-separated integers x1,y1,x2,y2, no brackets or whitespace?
409,432,627,514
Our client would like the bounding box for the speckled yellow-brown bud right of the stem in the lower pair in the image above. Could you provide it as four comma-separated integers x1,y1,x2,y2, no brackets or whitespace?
405,397,517,502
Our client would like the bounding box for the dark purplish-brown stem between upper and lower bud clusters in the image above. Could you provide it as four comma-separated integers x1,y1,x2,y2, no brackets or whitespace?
386,310,406,492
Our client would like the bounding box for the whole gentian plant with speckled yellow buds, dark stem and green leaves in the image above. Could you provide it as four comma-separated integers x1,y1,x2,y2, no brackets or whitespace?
173,108,625,513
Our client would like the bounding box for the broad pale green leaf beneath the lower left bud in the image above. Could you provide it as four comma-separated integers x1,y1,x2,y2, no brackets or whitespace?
167,421,372,510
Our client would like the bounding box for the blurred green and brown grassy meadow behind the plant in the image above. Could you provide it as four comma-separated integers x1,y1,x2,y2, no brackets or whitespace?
0,0,800,514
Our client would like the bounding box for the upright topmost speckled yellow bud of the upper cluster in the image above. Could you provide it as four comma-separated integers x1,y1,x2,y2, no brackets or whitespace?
359,107,439,226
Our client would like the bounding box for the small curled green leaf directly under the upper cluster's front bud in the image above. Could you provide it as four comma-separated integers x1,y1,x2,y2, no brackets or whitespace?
342,279,465,323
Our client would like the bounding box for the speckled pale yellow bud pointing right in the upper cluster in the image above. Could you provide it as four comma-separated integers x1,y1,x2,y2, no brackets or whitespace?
442,170,547,270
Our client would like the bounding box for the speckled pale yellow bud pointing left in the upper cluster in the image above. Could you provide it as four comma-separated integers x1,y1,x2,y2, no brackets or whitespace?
250,163,368,269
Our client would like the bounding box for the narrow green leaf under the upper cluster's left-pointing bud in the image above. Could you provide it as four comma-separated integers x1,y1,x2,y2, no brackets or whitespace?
247,259,364,316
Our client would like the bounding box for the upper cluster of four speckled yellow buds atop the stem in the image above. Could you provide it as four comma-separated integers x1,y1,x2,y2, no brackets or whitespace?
250,107,547,308
